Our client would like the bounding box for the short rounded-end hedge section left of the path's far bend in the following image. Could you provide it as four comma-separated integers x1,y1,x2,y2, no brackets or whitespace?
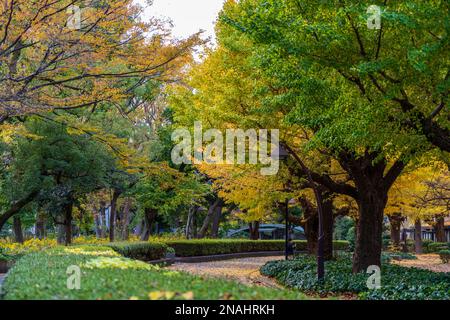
107,242,168,261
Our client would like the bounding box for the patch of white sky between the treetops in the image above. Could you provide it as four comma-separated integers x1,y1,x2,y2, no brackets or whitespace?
135,0,224,38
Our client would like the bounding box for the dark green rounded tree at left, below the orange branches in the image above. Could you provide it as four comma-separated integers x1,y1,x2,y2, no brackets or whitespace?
5,118,115,245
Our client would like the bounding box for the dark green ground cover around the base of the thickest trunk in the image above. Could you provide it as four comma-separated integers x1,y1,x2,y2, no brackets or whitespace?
261,252,450,300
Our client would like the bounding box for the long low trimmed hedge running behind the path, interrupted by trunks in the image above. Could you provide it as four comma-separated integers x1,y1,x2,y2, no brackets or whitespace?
164,239,349,257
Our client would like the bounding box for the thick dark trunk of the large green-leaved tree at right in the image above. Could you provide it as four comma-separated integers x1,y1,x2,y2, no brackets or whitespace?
353,188,387,273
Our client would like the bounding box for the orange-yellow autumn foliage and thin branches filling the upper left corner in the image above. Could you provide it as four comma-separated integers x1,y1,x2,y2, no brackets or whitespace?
0,0,199,123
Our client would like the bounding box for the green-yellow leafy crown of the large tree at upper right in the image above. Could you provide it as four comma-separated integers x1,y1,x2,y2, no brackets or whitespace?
219,0,450,155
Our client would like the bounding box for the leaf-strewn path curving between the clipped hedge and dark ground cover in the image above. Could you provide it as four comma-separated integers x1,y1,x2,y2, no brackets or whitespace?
168,256,282,288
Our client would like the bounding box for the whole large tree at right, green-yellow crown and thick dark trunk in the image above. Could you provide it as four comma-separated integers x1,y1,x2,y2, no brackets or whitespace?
221,0,450,272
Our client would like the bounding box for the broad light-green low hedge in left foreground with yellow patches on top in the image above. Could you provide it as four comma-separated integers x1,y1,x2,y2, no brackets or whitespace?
1,246,303,300
